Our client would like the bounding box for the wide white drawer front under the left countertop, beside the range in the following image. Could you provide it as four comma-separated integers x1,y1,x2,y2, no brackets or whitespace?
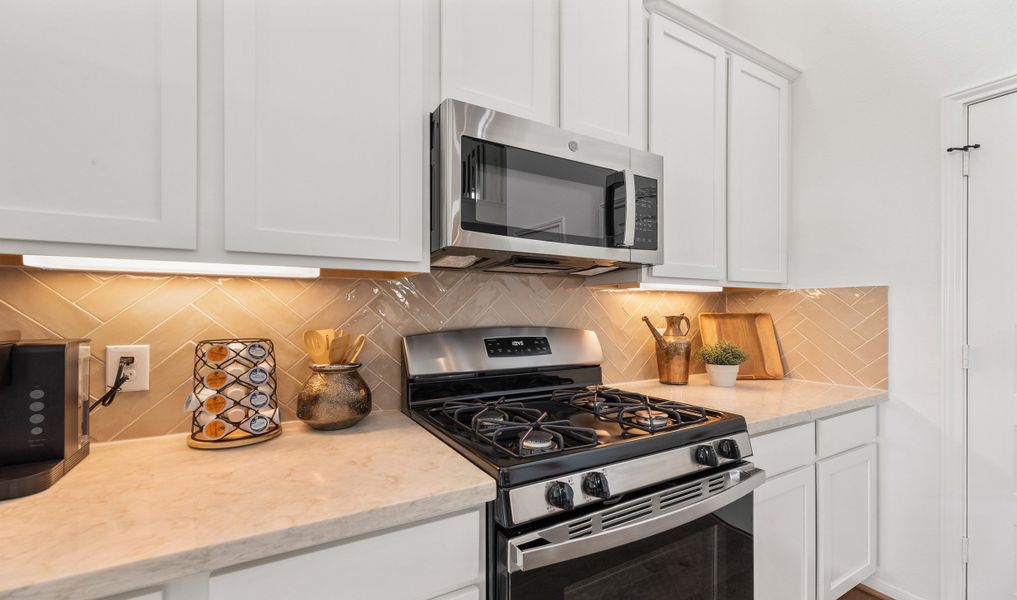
208,511,481,600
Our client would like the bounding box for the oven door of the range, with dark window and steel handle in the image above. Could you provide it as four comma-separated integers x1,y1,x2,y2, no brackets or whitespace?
496,464,764,600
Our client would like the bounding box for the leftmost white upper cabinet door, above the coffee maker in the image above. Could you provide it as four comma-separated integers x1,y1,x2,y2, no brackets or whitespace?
0,0,197,253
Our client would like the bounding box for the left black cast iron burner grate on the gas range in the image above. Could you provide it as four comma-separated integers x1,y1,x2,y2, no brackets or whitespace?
438,398,597,458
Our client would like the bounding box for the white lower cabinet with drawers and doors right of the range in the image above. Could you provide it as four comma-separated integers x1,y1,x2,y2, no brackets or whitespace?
751,416,878,600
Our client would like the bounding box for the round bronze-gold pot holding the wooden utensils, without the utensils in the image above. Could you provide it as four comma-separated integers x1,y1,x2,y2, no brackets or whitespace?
297,363,371,429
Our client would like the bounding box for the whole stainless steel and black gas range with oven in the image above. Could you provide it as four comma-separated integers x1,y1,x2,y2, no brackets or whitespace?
403,327,764,600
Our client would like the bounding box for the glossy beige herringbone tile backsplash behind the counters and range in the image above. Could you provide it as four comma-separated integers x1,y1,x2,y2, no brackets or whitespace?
0,267,886,440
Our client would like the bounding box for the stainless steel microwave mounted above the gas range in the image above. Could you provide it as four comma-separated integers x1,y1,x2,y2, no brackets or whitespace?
430,100,663,276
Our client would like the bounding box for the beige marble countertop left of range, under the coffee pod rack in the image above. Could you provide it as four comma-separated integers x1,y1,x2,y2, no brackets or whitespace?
0,413,494,600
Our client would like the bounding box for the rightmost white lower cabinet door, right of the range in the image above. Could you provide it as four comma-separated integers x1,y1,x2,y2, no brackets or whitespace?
816,443,877,600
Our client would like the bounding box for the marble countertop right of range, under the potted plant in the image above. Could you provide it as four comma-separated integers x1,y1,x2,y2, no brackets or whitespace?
612,374,889,435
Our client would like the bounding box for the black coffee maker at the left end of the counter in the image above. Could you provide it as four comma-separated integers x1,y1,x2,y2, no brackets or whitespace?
0,340,89,500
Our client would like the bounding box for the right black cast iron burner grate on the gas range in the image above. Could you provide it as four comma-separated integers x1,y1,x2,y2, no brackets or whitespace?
551,385,707,433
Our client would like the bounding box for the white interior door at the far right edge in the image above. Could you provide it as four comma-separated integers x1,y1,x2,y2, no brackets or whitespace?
967,89,1017,600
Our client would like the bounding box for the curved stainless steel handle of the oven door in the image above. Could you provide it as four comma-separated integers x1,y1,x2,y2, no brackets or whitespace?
507,466,766,573
